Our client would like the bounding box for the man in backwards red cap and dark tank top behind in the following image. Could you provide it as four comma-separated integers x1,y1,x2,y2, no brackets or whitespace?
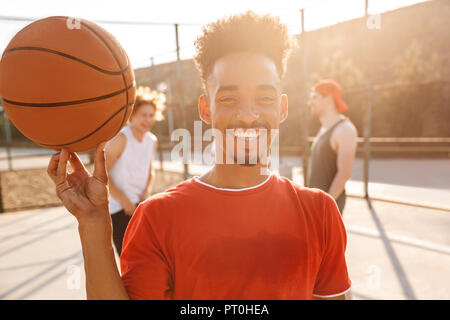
307,80,357,214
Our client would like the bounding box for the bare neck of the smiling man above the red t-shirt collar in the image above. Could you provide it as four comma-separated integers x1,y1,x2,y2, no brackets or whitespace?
200,164,270,189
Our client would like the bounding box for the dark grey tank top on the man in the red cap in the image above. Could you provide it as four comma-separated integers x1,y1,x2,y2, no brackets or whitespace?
308,116,347,214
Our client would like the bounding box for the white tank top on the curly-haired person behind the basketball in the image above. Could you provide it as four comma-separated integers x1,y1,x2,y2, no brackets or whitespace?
109,126,157,214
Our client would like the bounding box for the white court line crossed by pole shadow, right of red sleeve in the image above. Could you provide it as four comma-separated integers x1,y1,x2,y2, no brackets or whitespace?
345,225,450,255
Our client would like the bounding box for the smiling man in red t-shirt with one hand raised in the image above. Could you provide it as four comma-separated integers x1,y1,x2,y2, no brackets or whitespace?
48,12,351,299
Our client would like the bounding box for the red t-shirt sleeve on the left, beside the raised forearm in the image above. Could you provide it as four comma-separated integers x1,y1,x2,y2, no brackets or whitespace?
120,201,173,300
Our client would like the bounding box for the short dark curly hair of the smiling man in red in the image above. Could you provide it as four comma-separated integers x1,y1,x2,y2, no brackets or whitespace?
194,11,294,84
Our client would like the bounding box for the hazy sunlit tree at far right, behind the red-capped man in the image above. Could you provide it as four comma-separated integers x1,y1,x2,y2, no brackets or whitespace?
380,40,450,136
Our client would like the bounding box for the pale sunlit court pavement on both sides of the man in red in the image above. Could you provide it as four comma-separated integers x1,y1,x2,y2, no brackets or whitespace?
0,181,450,299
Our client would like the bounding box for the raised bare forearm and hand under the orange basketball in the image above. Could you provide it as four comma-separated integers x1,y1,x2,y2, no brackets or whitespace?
47,143,128,300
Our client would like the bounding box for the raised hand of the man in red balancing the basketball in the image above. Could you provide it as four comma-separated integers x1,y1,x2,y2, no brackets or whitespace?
47,143,109,222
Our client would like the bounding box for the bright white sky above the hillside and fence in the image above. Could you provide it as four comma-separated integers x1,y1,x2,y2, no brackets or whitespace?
0,0,424,68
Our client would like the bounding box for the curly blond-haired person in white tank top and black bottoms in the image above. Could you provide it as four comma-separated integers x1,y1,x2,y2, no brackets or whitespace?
105,87,165,256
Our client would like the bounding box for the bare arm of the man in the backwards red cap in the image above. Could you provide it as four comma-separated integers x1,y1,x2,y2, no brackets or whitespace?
328,123,357,199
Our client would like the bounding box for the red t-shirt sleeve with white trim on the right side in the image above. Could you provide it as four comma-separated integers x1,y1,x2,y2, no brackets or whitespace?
313,193,351,298
